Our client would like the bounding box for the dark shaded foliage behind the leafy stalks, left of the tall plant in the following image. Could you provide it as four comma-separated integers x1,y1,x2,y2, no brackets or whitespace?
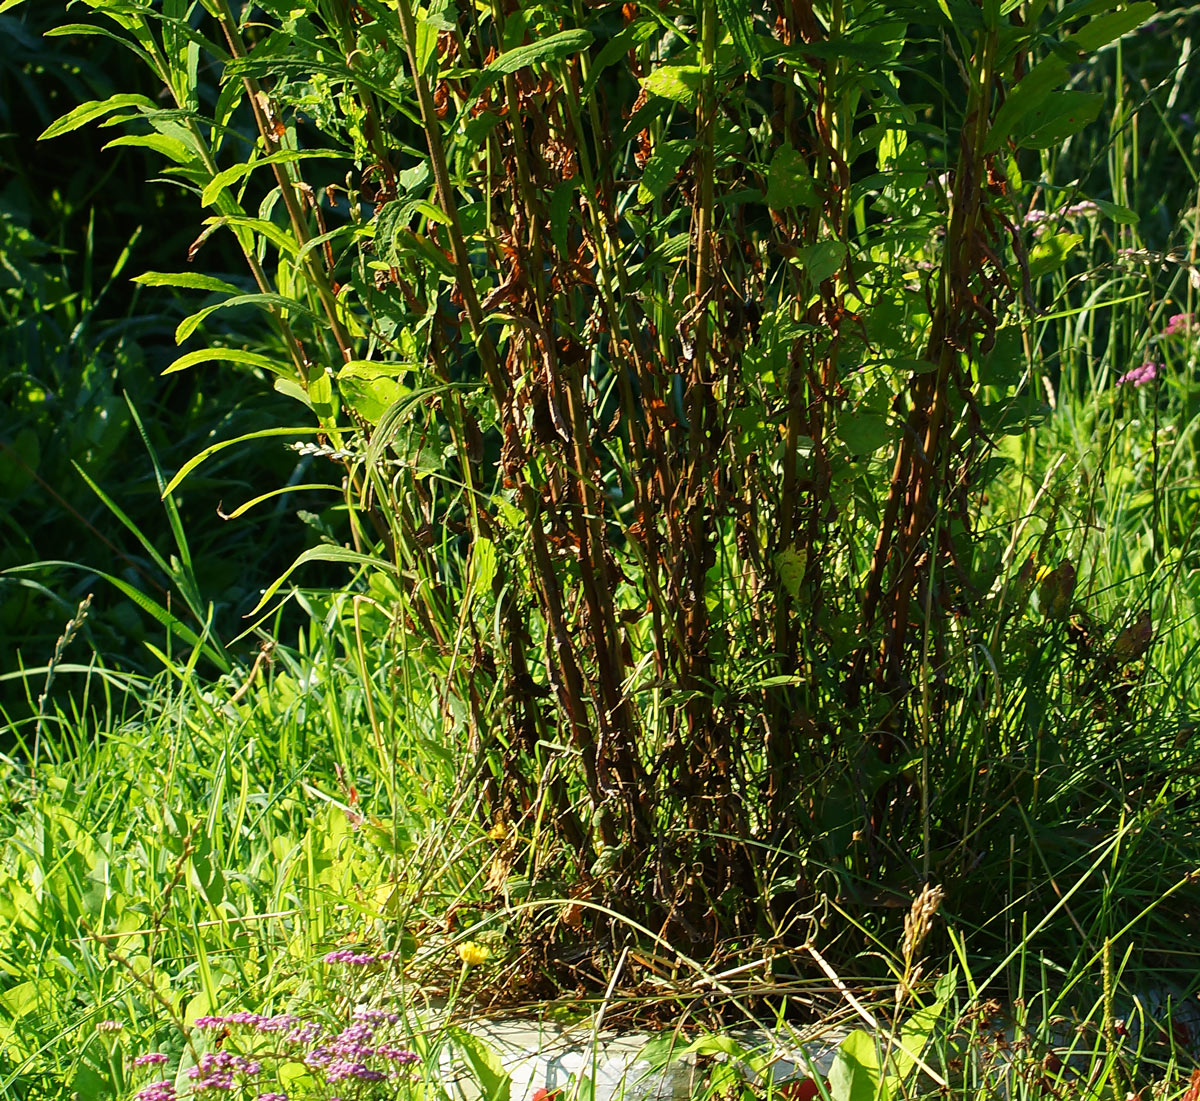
0,2,343,721
